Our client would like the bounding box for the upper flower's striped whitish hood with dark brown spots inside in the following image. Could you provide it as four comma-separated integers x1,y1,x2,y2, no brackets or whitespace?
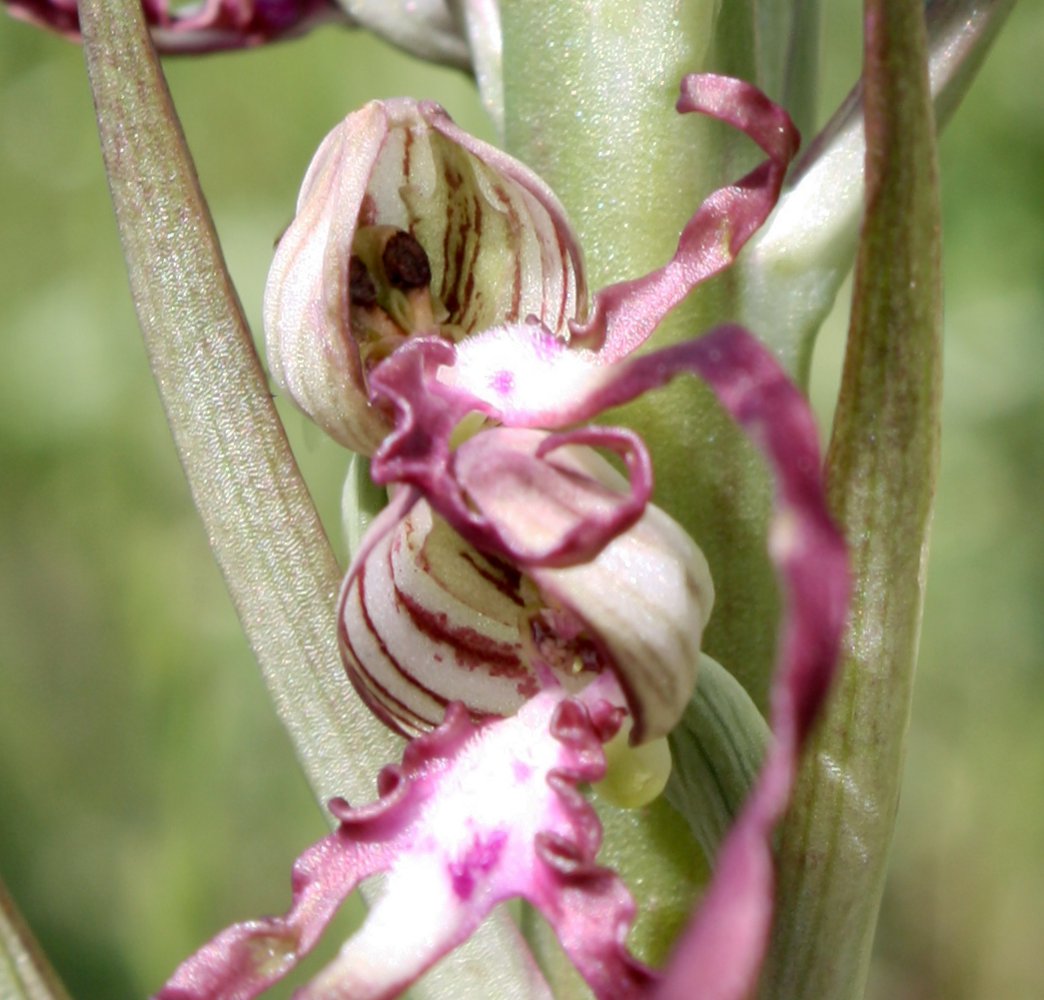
264,99,587,454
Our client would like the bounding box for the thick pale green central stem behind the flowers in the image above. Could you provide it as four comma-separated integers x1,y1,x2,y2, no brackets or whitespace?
501,0,778,707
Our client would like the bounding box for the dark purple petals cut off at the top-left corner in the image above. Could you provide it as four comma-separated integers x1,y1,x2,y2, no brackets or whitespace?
6,0,350,55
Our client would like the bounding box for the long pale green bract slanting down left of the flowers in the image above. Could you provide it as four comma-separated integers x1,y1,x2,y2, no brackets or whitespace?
80,0,548,1000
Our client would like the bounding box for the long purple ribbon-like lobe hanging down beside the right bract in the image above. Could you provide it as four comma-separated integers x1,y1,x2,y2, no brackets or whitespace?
654,327,850,1000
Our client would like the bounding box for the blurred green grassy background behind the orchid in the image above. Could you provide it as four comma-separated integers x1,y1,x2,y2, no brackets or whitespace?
0,2,1044,1000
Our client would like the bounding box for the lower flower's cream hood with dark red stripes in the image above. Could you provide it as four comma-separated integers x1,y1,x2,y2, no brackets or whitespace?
339,430,714,741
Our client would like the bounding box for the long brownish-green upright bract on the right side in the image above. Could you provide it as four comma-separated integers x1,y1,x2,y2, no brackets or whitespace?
761,0,942,1000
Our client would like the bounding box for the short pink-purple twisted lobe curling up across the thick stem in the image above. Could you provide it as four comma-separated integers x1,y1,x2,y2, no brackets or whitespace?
571,73,801,362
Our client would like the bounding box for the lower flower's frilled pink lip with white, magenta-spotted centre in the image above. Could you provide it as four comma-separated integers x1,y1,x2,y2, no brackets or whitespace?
156,676,657,1000
